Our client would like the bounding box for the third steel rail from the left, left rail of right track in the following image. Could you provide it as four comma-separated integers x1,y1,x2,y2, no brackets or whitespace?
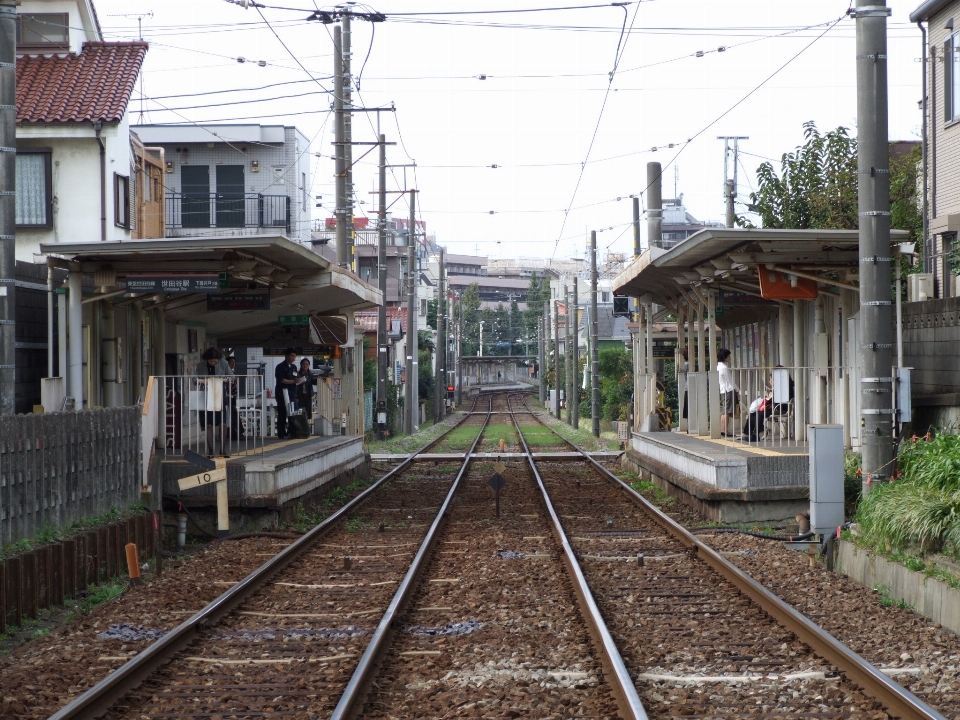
507,397,647,720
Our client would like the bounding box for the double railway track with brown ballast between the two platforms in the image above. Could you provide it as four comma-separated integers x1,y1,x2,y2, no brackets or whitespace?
43,396,942,720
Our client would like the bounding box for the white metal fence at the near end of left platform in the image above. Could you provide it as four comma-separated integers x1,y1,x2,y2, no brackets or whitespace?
153,374,272,456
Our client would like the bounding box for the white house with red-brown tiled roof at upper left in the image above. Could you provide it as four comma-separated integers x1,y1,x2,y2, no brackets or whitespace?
16,0,147,262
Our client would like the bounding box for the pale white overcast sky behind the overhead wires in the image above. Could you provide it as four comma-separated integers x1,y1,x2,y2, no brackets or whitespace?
95,0,921,258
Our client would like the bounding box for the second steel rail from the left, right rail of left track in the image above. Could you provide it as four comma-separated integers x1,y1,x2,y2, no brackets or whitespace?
330,395,493,720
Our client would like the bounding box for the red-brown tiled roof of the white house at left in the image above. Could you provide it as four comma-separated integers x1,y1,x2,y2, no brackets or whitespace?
17,42,147,123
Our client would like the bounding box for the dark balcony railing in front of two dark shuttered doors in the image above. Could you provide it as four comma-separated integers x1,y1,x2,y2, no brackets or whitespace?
166,193,290,233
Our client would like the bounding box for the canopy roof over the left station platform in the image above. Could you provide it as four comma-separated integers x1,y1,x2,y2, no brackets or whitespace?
41,235,383,344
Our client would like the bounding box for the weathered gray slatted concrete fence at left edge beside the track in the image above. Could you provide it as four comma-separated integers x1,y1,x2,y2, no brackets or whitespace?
0,407,141,543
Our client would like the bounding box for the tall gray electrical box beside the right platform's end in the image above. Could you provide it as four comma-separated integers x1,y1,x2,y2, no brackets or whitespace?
808,425,844,535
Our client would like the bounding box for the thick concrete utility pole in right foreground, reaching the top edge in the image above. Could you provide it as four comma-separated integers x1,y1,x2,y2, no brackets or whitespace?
854,0,894,494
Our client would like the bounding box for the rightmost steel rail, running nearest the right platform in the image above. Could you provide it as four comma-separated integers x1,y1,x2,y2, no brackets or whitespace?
517,396,946,720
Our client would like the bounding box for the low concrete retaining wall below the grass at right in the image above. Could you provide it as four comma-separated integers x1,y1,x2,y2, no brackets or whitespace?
836,540,960,632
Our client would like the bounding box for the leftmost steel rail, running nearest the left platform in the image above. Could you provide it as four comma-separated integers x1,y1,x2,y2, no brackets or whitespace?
48,398,484,720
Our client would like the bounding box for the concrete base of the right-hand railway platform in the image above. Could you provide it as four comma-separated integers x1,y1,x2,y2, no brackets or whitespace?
623,432,810,523
